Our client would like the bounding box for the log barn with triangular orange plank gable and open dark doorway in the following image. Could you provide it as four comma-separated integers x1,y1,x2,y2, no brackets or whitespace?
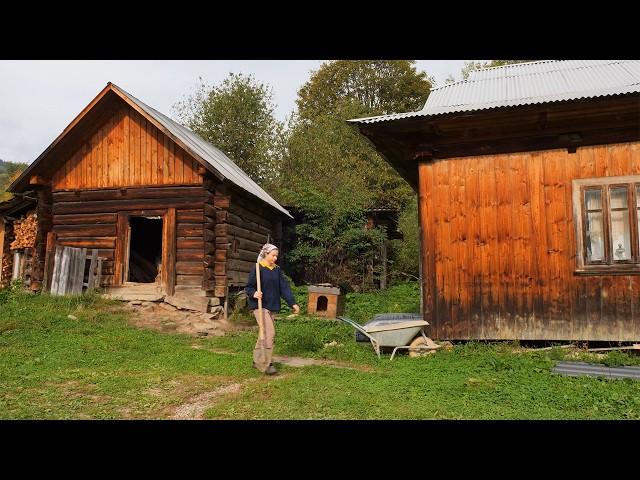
9,83,290,311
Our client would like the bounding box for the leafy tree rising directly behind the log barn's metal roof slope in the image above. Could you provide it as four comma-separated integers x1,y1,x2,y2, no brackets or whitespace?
173,73,283,188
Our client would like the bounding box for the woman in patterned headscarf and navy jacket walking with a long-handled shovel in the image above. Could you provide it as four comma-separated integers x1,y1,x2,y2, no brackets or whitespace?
246,243,300,375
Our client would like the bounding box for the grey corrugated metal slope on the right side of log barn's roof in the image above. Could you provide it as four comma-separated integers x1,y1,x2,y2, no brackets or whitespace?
111,84,293,218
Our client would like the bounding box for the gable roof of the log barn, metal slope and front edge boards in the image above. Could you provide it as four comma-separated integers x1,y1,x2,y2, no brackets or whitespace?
9,82,293,218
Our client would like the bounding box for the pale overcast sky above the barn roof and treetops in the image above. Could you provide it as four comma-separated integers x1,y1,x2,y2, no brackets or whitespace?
0,60,466,163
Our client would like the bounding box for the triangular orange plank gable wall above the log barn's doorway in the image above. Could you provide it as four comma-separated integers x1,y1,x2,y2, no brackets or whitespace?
52,106,202,191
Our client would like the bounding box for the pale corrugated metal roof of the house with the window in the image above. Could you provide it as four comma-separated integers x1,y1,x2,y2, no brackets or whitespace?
349,60,640,123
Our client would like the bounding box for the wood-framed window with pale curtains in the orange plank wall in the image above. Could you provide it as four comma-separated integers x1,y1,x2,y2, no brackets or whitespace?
573,176,640,274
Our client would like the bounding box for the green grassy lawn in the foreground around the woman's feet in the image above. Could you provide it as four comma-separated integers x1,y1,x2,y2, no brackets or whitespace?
0,284,640,419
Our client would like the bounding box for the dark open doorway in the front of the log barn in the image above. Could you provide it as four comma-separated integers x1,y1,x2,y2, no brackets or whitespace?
127,217,162,283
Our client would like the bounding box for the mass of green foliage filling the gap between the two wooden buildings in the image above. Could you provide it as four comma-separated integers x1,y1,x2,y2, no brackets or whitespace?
274,60,431,288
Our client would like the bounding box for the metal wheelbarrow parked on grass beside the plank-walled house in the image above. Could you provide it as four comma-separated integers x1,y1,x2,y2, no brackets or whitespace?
336,314,440,360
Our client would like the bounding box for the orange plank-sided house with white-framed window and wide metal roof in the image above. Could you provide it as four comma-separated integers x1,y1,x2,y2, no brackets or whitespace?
350,60,640,341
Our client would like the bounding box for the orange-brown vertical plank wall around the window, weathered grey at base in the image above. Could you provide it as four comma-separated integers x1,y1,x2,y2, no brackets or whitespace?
418,142,640,341
